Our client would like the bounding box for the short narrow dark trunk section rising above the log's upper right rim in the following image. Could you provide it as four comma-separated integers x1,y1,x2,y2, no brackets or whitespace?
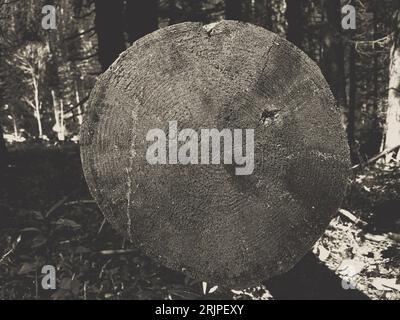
286,0,305,50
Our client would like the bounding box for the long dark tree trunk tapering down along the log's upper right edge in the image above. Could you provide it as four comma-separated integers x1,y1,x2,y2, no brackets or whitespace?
321,0,347,111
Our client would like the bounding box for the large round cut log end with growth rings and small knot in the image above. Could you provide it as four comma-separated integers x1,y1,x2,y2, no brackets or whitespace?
81,21,350,288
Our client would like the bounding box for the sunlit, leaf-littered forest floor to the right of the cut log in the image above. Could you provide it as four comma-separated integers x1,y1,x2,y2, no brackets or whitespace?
313,164,400,300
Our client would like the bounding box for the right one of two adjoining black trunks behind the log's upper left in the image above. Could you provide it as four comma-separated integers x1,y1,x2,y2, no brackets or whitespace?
126,0,158,43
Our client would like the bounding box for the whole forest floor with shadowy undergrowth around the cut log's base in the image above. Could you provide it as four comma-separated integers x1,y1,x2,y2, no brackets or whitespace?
0,145,400,300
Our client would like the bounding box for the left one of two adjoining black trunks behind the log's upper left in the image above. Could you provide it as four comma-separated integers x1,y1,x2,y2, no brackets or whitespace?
95,0,126,71
